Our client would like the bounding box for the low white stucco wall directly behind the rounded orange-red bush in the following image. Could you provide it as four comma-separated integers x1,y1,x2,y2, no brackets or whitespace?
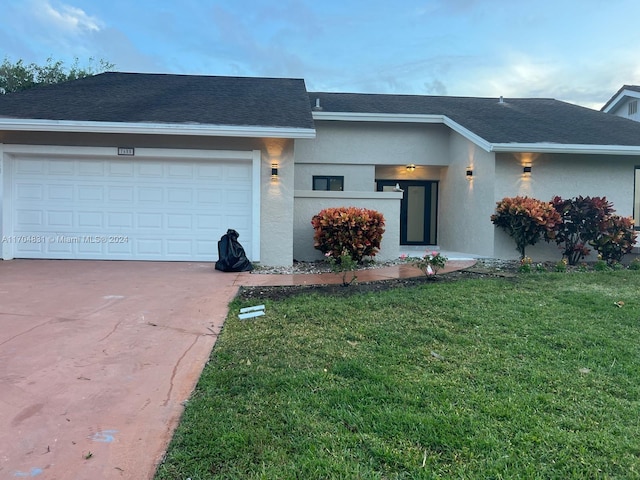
293,190,402,262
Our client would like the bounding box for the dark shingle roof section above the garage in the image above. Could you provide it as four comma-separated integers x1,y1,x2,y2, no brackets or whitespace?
0,72,313,129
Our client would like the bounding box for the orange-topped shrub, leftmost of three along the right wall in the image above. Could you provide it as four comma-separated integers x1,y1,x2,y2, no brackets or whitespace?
491,196,562,258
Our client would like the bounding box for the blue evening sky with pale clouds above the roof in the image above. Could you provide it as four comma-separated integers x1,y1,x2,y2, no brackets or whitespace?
0,0,640,109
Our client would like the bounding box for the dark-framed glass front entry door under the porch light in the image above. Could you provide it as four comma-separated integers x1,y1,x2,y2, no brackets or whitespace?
376,180,438,245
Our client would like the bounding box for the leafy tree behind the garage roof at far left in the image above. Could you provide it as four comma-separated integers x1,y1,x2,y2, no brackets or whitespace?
0,57,114,94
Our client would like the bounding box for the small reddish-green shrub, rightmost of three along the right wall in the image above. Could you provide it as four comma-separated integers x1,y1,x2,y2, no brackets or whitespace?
589,215,637,265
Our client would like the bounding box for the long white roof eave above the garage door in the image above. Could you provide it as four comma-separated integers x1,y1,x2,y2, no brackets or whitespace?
0,118,316,138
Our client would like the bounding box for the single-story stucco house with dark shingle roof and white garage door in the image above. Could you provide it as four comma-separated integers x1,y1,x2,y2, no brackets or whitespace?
0,72,640,265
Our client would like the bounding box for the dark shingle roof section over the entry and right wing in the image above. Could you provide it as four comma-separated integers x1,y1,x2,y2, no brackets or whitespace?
309,92,640,146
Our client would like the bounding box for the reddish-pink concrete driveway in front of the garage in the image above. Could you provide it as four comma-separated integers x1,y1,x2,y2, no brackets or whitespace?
0,260,238,480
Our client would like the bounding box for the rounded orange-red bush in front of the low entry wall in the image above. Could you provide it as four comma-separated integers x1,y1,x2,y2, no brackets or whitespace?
311,207,384,262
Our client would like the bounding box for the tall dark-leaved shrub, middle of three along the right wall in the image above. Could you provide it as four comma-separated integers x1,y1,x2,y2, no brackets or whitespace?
551,196,615,265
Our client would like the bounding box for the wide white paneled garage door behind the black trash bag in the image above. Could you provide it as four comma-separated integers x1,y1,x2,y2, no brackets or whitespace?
8,158,252,261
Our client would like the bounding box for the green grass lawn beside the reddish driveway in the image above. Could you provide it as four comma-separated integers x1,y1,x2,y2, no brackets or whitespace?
156,271,640,480
